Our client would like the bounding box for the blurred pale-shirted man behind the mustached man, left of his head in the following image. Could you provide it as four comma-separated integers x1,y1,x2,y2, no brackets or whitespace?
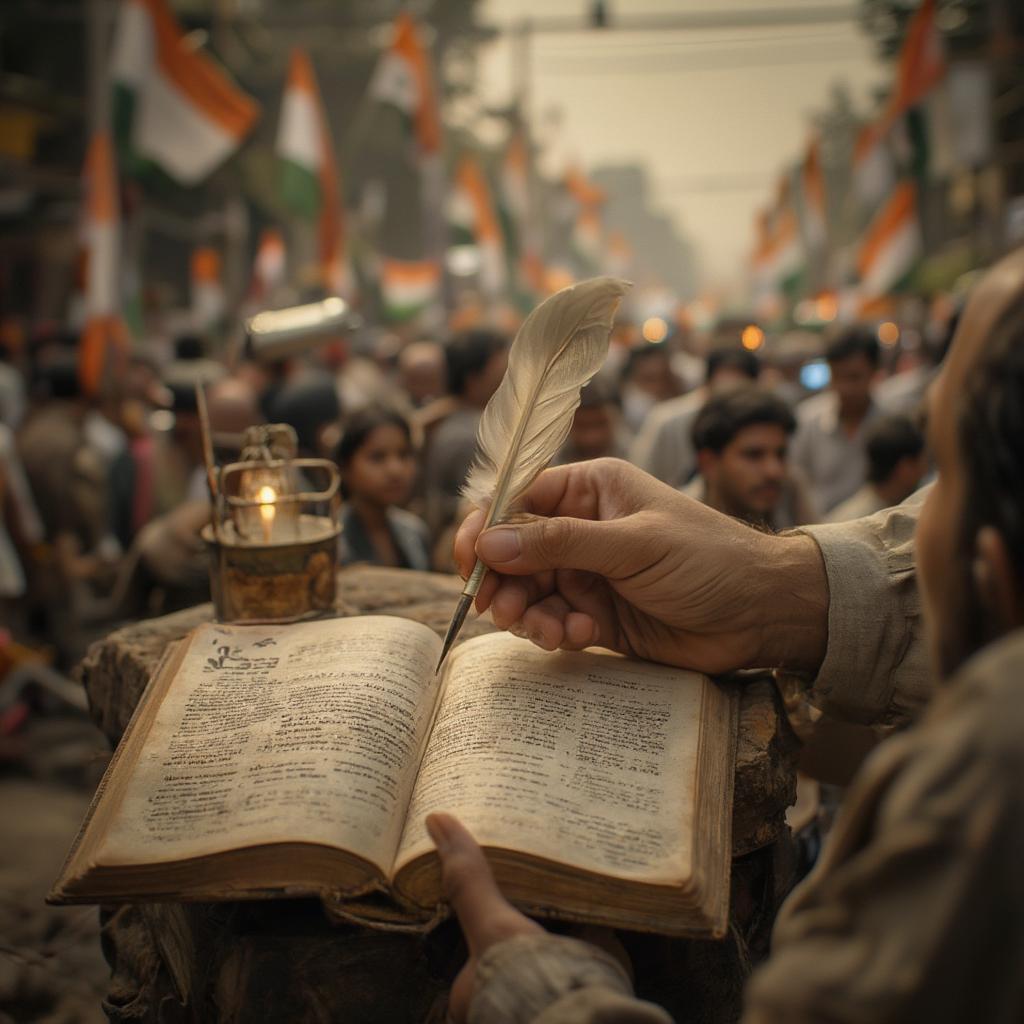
630,345,761,487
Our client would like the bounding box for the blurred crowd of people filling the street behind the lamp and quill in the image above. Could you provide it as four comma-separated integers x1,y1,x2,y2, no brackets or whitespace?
0,299,951,664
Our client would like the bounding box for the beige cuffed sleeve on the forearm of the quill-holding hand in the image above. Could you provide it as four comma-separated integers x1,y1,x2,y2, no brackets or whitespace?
801,487,932,726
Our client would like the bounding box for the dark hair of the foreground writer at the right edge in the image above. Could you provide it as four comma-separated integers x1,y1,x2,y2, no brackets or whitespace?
957,295,1024,581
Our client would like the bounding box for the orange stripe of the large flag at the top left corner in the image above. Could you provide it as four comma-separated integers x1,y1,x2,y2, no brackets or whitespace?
145,0,259,138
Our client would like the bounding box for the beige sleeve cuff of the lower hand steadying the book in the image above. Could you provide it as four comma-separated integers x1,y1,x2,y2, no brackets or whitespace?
469,934,672,1024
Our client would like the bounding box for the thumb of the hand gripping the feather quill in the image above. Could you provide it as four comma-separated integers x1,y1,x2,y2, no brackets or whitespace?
476,516,628,575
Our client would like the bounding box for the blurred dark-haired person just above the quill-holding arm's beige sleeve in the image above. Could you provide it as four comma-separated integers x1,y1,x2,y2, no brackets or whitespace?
827,416,928,522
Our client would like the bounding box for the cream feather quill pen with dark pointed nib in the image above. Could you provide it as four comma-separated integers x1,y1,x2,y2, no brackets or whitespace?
437,278,631,670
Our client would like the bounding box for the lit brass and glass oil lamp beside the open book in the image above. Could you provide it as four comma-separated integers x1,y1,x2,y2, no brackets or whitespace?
203,423,341,623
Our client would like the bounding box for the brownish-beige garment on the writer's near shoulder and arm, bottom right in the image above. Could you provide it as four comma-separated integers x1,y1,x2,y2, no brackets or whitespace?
742,659,1024,1024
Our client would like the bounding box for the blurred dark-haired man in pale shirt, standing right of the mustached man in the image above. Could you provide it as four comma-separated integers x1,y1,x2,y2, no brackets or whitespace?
793,327,881,512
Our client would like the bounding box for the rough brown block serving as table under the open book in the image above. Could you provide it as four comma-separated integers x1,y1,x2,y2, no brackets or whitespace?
79,566,797,1024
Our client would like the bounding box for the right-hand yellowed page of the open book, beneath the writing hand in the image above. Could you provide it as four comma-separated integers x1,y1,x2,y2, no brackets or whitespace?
396,634,705,881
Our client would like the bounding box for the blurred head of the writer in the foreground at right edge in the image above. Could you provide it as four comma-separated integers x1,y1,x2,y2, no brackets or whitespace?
914,249,1024,675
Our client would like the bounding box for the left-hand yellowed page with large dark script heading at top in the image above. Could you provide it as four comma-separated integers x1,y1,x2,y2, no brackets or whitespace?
98,615,440,870
